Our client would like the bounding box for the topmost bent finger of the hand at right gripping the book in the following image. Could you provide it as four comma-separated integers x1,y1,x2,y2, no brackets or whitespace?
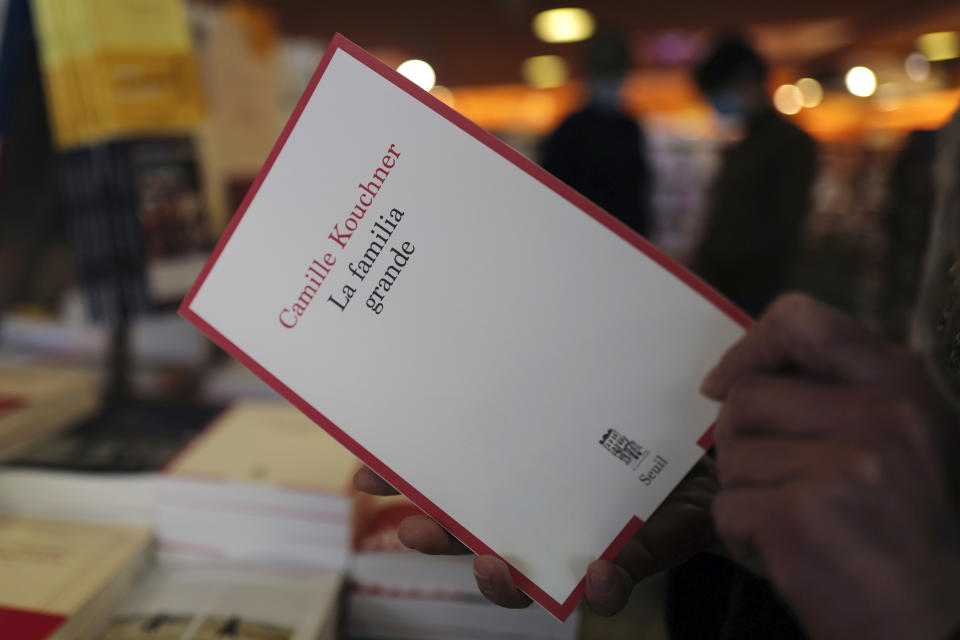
701,294,892,400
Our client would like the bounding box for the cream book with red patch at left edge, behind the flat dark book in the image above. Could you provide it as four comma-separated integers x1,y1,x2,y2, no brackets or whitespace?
0,360,100,460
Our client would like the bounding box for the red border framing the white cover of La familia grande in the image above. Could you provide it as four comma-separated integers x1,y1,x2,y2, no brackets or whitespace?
180,33,752,620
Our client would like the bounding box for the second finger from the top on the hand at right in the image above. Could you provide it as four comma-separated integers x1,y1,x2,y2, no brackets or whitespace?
716,374,876,442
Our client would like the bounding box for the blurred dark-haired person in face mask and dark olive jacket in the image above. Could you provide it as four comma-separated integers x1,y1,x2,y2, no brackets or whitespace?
692,36,816,315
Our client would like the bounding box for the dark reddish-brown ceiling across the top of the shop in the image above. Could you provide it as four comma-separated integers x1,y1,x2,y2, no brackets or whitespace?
201,0,960,86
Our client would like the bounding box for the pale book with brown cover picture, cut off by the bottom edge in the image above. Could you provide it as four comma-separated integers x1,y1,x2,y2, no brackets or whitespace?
97,565,342,640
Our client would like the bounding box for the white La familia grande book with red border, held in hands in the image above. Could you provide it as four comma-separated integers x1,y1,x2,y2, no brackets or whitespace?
180,36,750,619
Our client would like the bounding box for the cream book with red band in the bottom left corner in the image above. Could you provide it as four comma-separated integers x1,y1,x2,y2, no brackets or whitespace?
0,516,151,640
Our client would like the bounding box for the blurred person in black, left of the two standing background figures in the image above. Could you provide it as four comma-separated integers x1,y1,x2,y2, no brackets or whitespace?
541,32,651,235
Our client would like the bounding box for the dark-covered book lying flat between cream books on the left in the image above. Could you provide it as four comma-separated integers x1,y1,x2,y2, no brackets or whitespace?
7,405,223,473
